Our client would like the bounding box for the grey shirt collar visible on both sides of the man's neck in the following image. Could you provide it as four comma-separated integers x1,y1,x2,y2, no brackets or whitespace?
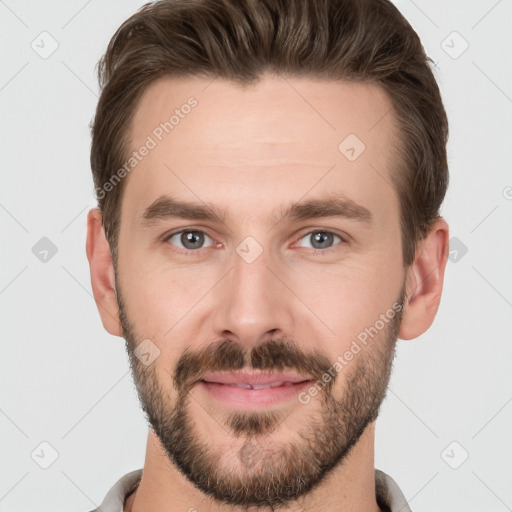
91,469,412,512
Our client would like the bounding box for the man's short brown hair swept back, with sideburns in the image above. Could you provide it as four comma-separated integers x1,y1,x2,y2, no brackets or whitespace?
91,0,448,266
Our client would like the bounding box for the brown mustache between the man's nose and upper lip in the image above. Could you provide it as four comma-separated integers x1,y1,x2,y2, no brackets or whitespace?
173,339,335,394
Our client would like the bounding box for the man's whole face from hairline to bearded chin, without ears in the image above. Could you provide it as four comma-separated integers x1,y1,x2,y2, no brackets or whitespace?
115,76,405,507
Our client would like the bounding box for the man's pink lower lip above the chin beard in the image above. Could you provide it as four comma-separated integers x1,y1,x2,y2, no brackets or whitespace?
199,380,313,408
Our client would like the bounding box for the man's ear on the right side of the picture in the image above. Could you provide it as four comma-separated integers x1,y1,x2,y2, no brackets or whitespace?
398,218,449,340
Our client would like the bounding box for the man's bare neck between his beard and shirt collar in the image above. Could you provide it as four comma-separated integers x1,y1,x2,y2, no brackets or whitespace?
124,423,381,512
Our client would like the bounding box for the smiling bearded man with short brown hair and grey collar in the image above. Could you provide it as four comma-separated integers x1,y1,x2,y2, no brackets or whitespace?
87,0,448,512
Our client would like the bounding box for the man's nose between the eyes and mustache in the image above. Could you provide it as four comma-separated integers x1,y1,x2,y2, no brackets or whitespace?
213,241,297,346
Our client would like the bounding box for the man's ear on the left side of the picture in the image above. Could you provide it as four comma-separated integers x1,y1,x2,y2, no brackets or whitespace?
86,208,122,336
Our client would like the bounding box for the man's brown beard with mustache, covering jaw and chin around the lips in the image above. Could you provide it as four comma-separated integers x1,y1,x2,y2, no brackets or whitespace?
116,278,405,510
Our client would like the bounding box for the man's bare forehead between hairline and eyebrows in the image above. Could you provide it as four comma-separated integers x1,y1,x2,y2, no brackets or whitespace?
123,76,398,226
